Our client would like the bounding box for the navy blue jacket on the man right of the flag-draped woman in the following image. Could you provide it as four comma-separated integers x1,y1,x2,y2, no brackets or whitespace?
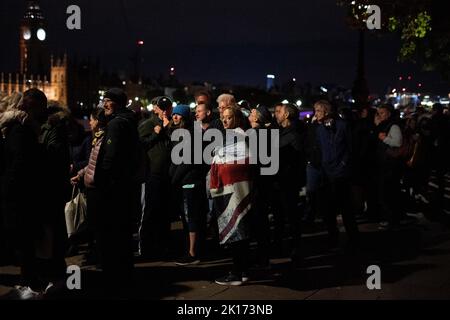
317,118,352,179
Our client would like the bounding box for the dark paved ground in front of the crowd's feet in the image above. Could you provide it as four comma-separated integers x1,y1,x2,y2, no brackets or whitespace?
0,215,450,300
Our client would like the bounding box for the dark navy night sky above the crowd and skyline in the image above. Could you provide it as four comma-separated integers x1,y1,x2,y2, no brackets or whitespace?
0,0,447,93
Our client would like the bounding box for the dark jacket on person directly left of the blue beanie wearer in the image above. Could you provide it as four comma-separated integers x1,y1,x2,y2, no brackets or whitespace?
139,114,171,177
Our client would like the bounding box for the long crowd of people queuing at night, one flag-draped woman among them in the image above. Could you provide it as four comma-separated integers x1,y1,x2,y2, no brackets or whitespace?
0,88,450,297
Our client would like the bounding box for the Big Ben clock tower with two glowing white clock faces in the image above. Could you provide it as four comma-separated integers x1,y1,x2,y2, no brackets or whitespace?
19,1,49,75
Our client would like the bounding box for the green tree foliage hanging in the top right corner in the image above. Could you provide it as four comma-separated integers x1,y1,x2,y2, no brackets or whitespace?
338,0,450,80
